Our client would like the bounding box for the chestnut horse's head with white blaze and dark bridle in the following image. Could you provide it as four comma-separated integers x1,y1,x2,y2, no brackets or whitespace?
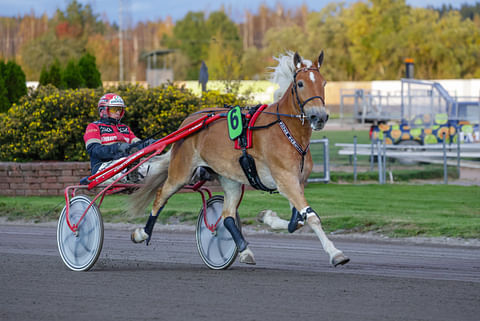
292,51,328,130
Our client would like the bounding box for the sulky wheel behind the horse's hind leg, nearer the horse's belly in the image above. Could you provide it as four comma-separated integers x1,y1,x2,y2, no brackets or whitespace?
195,195,241,270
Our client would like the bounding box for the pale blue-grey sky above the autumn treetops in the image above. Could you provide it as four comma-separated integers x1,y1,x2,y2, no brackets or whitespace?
0,0,480,24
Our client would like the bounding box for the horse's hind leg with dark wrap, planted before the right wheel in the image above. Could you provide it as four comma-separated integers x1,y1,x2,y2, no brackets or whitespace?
219,176,256,264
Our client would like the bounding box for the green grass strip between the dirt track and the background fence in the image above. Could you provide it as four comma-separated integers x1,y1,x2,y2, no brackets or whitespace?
0,184,480,238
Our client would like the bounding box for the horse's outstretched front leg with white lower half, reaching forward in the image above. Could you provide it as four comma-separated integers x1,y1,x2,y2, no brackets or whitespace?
277,178,350,266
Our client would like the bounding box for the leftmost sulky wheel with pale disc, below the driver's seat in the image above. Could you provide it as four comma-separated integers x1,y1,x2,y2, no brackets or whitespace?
57,195,103,271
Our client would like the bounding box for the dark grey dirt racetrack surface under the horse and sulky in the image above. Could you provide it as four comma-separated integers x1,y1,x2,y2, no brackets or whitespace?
0,225,480,321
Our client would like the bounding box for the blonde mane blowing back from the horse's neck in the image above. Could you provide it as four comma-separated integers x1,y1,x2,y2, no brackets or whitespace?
269,51,312,101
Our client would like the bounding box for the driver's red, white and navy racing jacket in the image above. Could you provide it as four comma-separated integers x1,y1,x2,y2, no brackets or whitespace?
83,118,140,175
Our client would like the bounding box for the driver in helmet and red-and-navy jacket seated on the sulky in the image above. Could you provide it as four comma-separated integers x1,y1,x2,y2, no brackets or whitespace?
83,93,155,179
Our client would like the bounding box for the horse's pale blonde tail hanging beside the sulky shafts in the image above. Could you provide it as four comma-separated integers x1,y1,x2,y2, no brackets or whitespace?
129,150,171,217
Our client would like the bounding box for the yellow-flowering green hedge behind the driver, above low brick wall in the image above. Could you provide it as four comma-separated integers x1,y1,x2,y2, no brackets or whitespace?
0,84,246,162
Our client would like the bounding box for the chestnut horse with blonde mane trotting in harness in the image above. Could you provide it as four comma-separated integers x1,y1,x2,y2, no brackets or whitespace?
131,51,349,266
